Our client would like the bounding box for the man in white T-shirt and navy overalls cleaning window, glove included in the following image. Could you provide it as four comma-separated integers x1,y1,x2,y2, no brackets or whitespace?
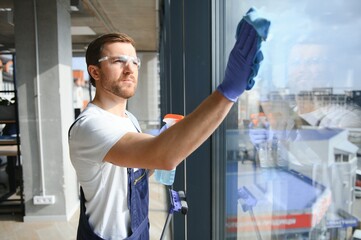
69,10,269,239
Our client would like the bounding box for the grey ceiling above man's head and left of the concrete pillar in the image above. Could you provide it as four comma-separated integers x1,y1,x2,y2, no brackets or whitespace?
0,0,159,52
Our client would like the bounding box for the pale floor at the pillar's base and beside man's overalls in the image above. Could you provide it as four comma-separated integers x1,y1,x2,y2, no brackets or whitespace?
0,176,170,240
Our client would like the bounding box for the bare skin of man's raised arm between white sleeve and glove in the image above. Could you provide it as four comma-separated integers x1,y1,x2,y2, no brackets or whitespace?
105,91,233,170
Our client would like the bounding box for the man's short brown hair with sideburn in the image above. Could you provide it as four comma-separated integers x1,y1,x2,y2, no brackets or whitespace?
85,33,135,87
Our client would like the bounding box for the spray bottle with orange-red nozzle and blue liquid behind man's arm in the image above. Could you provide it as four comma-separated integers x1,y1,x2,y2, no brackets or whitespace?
154,114,184,186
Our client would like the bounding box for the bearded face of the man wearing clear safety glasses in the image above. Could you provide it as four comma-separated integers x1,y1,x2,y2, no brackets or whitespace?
96,42,138,99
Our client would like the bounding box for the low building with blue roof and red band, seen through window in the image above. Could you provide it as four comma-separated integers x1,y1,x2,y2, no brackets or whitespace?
226,165,331,239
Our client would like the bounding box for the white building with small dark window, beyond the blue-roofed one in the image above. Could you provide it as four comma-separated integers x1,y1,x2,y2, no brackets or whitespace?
287,129,358,212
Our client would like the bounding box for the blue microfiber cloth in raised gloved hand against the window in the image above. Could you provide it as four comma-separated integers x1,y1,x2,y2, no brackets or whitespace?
236,7,271,90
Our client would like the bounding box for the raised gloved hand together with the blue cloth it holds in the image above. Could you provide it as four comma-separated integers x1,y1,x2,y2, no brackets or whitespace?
217,8,270,102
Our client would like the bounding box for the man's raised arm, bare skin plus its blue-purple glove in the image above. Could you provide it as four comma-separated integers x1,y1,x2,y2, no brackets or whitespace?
105,8,269,170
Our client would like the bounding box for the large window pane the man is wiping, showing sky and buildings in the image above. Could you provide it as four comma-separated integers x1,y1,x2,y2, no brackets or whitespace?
224,0,361,239
